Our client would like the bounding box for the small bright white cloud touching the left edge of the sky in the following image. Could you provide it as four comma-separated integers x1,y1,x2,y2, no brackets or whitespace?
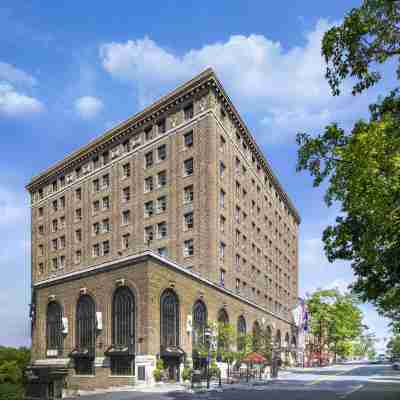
0,82,44,116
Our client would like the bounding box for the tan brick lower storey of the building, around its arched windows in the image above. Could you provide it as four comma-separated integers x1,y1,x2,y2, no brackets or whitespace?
29,252,294,399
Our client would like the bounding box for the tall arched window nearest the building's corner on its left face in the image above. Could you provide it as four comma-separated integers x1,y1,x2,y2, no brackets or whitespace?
108,286,135,375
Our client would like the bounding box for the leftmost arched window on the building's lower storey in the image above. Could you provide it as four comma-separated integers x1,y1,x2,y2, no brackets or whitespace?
46,301,63,356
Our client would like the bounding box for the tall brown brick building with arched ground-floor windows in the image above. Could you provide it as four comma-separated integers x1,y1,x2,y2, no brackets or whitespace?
27,69,300,391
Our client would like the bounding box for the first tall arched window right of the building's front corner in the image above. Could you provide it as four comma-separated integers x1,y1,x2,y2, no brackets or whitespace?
160,289,179,348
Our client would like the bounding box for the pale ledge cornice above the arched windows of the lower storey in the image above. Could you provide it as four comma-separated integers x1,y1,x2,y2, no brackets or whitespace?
32,250,293,325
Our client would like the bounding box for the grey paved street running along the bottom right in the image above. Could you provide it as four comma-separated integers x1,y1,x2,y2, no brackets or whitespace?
71,364,400,400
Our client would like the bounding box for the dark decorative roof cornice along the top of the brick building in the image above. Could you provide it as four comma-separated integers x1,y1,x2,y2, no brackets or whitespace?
26,68,301,223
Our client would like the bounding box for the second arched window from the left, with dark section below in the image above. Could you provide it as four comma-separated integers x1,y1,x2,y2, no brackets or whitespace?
75,295,96,375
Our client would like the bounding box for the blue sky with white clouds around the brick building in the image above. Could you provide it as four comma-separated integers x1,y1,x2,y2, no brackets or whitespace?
0,0,390,348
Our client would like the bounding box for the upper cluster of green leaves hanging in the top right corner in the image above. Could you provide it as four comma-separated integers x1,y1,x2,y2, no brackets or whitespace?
322,0,400,95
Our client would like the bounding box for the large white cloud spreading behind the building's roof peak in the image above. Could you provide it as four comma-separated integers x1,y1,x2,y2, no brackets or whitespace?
100,19,376,143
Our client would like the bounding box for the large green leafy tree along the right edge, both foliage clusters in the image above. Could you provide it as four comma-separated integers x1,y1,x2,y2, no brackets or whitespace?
297,0,400,328
